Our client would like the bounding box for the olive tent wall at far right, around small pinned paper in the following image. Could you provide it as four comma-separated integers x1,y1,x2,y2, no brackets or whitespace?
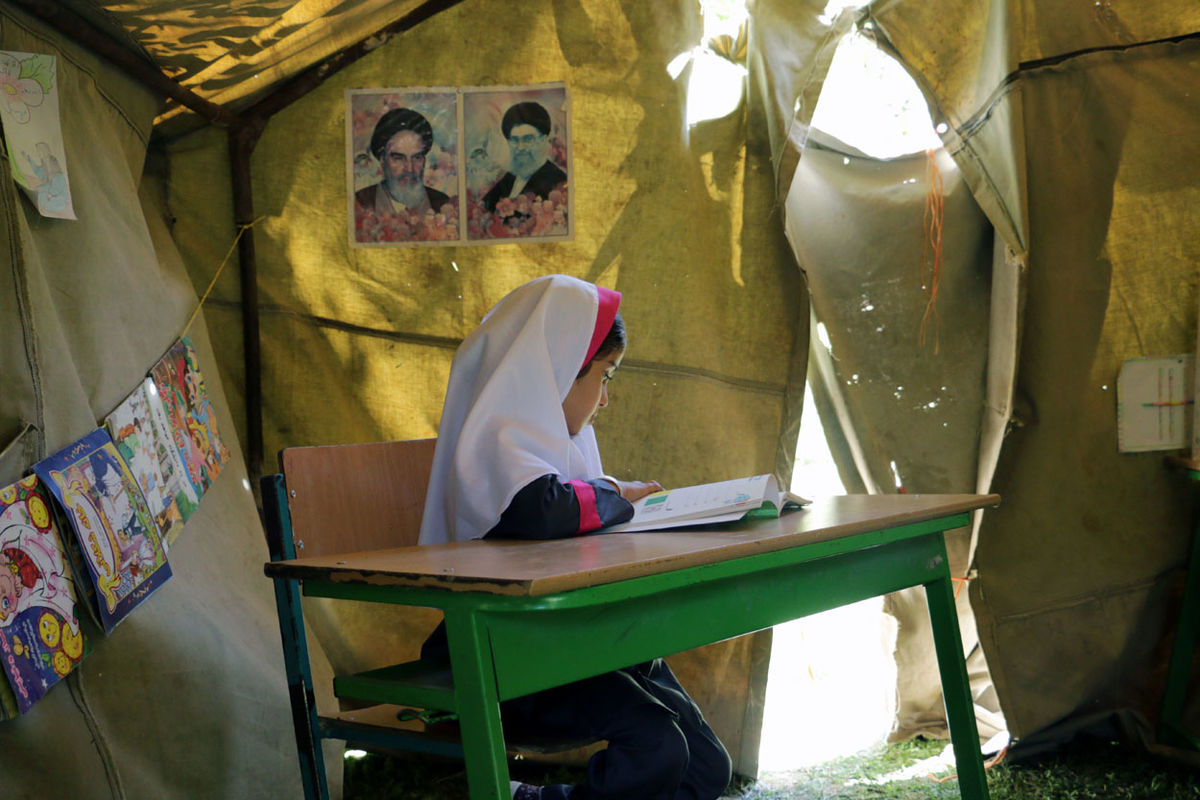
977,35,1200,753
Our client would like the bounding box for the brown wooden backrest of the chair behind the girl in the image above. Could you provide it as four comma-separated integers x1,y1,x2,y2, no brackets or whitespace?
280,439,437,557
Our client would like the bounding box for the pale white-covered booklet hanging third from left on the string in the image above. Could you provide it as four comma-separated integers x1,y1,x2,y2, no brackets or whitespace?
104,378,199,545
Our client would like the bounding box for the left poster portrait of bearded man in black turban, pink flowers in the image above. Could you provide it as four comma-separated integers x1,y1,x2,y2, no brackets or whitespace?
347,90,460,245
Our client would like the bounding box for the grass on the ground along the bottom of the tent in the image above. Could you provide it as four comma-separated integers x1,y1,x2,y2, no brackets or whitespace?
344,738,1200,800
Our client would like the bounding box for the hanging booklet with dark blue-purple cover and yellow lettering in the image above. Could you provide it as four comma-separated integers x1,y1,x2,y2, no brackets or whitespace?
34,428,170,633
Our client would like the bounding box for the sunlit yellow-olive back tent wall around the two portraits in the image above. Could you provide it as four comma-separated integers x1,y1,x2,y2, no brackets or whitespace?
167,1,808,774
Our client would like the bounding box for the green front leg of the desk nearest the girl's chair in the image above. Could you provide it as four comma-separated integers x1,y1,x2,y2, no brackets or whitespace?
445,608,511,800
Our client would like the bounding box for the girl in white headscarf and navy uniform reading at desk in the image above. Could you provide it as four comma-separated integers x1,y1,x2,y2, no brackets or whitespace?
420,275,731,800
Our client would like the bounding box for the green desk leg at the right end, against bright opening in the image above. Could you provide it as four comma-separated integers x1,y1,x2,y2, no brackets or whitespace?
925,568,988,800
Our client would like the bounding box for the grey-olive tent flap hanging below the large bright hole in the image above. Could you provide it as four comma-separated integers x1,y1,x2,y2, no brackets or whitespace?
787,139,1004,740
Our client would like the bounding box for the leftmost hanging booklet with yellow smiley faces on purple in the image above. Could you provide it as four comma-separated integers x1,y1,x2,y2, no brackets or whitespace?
0,475,88,714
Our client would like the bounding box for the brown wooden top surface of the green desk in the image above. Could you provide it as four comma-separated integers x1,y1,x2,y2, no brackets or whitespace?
265,494,1000,596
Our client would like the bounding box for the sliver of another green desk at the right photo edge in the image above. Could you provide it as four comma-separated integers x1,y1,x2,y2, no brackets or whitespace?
1158,457,1200,750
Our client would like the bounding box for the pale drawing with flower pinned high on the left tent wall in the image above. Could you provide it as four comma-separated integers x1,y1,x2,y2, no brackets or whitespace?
0,50,76,219
